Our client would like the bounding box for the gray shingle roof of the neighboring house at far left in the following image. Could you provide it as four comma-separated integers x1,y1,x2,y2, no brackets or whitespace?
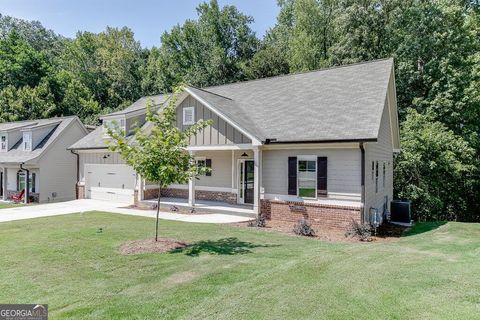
0,116,79,163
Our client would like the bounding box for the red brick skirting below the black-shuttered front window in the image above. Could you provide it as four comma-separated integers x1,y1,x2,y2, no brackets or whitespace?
261,200,362,231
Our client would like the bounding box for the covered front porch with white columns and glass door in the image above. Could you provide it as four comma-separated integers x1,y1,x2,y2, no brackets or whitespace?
136,144,262,216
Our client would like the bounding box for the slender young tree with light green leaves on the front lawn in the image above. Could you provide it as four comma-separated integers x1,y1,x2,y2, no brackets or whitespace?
108,87,209,241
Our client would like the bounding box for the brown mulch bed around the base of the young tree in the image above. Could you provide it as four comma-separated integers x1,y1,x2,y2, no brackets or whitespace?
119,238,189,255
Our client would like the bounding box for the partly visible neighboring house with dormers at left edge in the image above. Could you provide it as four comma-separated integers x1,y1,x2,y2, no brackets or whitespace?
0,117,88,202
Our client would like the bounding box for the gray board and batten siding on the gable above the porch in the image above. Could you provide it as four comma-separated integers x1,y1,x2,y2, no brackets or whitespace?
177,95,251,146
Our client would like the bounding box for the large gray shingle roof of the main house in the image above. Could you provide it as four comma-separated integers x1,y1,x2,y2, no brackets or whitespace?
70,59,393,149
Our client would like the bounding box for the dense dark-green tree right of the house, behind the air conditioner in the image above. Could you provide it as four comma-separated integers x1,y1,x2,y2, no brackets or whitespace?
394,110,480,221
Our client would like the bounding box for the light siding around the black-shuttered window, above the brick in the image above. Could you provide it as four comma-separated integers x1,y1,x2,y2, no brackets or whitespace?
262,148,361,200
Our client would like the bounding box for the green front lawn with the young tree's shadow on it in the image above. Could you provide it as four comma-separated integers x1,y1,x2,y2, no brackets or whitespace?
0,212,480,319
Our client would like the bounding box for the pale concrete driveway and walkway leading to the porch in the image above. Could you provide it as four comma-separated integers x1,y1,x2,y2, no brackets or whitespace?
0,199,252,223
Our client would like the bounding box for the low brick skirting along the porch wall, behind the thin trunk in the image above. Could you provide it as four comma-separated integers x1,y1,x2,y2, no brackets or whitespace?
144,188,237,204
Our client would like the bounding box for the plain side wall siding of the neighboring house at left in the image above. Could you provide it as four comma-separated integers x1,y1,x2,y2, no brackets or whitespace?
39,121,85,202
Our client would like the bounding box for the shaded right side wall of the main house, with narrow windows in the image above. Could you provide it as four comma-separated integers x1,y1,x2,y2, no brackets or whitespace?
365,103,393,218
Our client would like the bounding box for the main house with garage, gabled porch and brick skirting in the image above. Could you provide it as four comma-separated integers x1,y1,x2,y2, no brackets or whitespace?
67,59,400,228
